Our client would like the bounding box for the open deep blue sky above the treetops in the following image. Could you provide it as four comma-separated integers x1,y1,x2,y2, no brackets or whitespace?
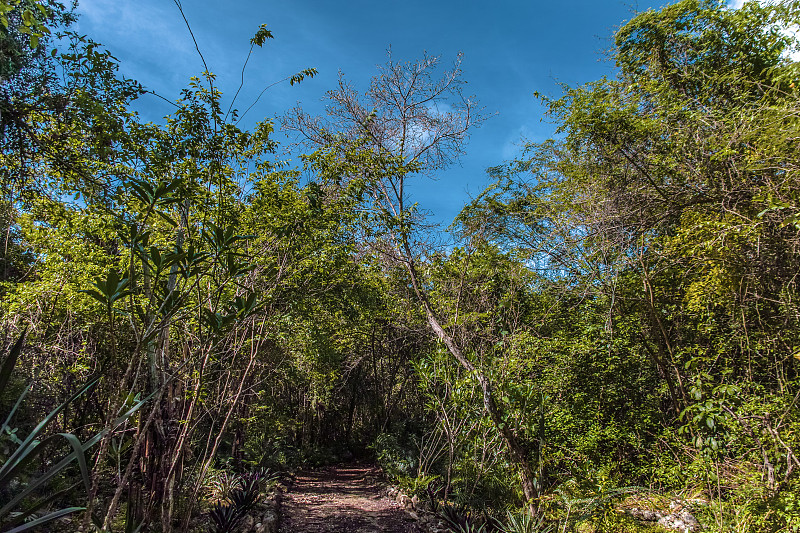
77,0,680,224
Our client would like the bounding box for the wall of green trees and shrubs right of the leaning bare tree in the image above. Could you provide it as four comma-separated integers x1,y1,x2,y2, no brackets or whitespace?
443,0,800,530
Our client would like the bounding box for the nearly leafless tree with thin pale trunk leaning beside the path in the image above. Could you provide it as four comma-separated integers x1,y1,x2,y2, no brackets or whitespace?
283,54,537,505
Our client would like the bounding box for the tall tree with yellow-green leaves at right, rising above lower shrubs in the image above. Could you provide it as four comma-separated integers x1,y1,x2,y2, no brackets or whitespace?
461,0,800,502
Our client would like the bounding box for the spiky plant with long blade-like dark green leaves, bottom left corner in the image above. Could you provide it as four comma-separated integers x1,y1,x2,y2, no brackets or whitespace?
0,331,150,533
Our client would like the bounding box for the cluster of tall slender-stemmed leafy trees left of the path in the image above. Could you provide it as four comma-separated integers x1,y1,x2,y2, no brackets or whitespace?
0,4,332,531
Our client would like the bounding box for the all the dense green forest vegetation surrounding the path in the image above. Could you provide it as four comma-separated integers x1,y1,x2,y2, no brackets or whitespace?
0,0,800,532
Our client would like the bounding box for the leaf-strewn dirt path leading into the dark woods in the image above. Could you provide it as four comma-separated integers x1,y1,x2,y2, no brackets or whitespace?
280,466,422,533
